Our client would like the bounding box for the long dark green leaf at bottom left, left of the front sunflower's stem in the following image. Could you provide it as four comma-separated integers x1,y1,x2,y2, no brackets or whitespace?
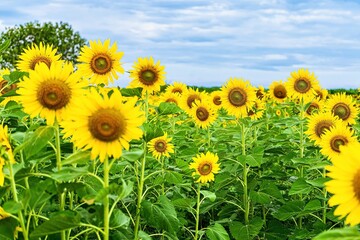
30,211,80,238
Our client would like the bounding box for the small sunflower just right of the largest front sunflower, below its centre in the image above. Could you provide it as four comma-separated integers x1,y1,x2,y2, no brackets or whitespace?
147,133,174,160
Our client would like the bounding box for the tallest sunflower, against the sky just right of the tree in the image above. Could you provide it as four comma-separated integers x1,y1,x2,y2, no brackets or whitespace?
78,39,124,85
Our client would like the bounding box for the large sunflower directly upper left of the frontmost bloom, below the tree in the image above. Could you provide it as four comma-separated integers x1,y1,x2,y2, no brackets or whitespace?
17,62,87,125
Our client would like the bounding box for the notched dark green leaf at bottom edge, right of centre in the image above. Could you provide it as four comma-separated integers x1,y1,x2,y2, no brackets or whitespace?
230,217,264,240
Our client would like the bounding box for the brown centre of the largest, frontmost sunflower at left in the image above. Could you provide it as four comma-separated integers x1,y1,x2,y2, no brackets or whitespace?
88,109,126,142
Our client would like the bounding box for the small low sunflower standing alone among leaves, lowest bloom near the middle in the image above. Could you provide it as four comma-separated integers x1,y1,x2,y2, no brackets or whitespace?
189,152,220,183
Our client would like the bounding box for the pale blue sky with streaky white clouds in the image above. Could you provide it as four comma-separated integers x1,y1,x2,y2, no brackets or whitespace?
0,0,360,89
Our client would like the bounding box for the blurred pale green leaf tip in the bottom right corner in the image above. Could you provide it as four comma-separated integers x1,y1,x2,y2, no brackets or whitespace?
313,227,360,240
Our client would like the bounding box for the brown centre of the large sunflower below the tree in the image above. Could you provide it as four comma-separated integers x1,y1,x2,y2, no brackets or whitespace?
37,80,71,110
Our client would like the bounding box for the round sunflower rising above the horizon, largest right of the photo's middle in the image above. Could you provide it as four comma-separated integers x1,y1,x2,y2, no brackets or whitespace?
221,78,256,118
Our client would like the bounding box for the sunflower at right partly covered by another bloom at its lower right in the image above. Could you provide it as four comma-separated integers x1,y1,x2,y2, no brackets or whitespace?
305,112,343,145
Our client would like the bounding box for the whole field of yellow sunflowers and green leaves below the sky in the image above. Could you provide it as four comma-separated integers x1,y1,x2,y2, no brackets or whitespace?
0,40,360,240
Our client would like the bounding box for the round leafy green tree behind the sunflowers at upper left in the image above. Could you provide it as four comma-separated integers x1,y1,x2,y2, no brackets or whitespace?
0,22,87,69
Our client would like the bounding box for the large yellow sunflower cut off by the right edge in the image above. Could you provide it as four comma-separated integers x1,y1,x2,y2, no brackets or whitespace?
325,142,360,226
